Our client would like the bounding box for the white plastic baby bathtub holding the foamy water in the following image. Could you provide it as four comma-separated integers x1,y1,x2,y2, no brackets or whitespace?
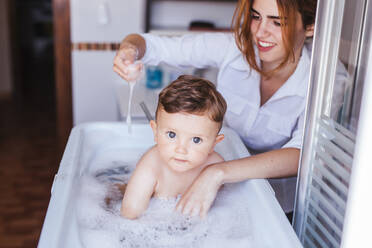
38,123,302,248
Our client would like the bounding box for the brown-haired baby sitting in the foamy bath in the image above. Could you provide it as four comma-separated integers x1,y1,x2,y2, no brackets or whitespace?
121,75,226,219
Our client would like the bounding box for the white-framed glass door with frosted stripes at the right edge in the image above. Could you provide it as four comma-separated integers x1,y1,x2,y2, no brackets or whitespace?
294,0,372,247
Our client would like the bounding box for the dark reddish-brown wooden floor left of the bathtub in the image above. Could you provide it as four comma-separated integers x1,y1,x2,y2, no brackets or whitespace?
0,97,60,248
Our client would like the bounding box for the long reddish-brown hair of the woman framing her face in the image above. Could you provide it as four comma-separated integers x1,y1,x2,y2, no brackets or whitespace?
232,0,317,76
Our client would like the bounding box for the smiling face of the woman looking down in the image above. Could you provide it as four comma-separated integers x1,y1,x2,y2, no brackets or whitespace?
251,0,306,69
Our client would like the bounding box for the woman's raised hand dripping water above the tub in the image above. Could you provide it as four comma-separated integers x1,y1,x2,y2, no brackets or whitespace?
113,44,143,82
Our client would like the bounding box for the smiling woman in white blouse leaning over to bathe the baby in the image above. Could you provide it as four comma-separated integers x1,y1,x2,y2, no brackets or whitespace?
114,0,316,216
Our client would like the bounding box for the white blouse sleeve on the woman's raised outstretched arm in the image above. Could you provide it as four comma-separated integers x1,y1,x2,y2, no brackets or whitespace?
142,33,233,69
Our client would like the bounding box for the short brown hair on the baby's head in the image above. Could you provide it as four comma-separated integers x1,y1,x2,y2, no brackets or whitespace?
156,75,227,127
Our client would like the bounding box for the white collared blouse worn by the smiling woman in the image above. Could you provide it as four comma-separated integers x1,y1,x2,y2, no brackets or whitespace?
143,33,310,153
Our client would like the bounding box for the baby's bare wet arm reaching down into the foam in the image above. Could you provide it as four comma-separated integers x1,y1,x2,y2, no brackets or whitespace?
120,149,156,219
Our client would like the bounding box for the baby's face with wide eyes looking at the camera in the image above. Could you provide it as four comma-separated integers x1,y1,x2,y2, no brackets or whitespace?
151,110,223,172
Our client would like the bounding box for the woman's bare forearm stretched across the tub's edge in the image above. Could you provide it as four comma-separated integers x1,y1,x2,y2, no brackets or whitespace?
215,148,300,183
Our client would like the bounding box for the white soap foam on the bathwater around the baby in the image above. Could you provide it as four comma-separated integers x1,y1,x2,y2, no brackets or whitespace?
76,163,255,248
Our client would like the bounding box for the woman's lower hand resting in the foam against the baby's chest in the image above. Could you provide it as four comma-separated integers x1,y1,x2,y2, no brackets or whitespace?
176,165,223,217
